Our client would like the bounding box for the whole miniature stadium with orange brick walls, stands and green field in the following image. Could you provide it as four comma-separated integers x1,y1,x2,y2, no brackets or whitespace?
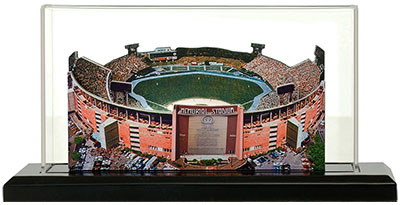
68,43,325,171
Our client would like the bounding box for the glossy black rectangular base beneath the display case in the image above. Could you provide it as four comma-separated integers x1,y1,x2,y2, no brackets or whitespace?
3,163,397,201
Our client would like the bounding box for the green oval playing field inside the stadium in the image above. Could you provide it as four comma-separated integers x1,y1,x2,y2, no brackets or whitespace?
133,74,263,110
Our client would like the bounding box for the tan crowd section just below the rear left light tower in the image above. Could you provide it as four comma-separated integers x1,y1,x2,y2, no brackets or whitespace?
104,55,147,81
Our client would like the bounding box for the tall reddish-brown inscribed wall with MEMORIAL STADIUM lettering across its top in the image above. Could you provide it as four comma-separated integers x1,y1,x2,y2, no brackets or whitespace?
172,105,243,160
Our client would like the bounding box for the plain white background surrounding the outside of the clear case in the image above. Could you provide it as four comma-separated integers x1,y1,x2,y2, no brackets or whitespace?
0,0,400,203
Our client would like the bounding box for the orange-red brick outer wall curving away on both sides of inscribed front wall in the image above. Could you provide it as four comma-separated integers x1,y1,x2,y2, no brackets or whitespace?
73,84,324,159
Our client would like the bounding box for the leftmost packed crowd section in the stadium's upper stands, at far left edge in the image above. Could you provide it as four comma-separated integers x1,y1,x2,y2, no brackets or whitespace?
73,57,110,99
